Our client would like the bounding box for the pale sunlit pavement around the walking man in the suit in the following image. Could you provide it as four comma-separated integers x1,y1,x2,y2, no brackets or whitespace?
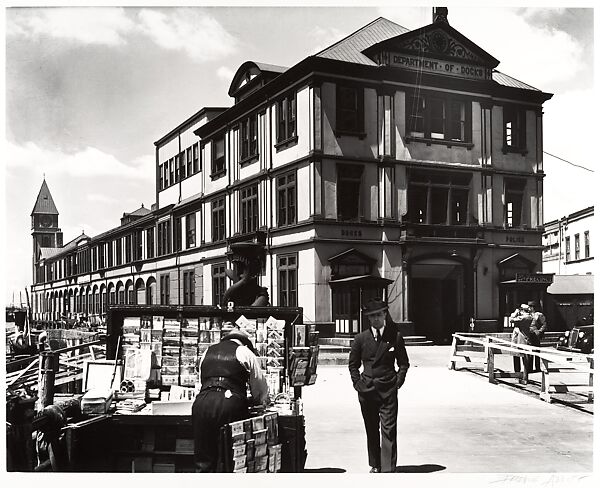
303,346,593,473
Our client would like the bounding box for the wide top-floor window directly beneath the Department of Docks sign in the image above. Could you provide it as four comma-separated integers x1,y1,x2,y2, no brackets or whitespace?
406,93,471,145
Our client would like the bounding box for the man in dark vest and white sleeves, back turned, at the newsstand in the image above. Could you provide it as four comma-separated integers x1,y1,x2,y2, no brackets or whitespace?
192,329,269,473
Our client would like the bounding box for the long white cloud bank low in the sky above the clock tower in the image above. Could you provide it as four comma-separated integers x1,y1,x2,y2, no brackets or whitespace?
6,142,154,180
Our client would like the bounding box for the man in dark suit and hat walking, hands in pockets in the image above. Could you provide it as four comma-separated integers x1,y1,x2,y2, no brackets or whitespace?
348,299,409,473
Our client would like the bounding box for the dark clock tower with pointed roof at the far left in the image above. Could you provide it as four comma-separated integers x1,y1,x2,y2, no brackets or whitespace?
31,179,63,283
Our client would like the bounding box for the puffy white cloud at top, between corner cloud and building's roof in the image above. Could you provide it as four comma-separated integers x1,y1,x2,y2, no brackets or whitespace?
138,8,237,61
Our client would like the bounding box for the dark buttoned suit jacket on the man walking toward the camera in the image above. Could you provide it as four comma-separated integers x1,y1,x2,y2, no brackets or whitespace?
348,322,409,397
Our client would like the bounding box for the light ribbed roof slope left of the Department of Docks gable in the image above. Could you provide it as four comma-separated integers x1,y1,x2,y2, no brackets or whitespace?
315,17,409,66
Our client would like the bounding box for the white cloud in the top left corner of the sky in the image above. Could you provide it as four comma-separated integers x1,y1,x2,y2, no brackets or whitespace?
7,7,135,46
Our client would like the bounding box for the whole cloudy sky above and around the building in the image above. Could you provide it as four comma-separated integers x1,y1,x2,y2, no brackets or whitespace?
0,2,597,303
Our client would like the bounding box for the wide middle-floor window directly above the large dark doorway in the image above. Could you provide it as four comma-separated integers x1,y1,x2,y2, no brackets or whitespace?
408,171,471,225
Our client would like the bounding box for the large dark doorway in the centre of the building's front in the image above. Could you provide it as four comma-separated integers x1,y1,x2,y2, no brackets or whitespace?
409,258,467,344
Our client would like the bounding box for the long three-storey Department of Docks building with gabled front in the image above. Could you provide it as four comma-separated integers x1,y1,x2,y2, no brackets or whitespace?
32,9,552,343
